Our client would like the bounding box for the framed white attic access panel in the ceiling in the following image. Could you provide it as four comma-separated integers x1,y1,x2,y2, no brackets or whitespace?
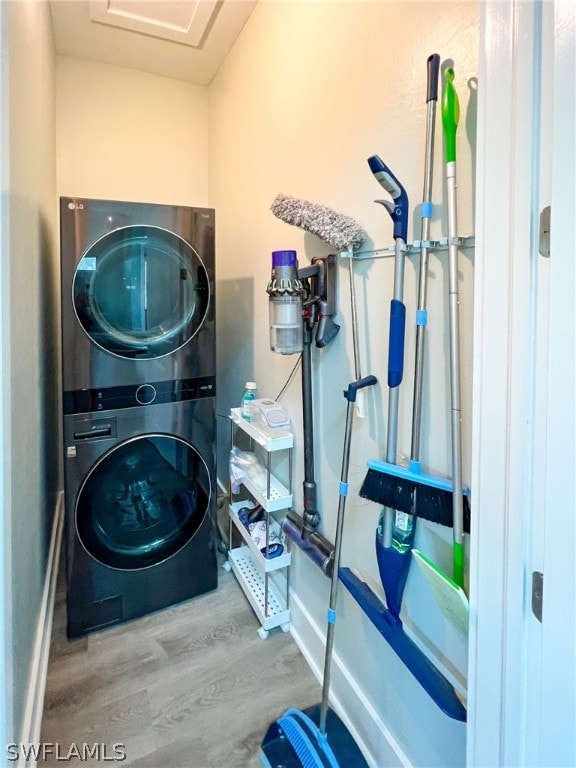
90,0,218,48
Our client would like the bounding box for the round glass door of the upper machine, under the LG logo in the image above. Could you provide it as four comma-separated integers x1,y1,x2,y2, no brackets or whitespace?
72,226,210,359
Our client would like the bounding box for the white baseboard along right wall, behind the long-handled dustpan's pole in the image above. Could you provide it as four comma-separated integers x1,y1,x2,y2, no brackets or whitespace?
290,591,412,768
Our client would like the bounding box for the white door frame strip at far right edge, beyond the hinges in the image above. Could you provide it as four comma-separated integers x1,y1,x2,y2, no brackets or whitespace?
537,0,576,768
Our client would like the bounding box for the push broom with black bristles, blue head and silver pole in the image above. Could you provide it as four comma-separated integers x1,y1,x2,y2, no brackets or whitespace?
360,54,470,531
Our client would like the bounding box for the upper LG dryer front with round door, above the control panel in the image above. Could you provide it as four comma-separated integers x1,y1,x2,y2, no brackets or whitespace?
60,198,215,396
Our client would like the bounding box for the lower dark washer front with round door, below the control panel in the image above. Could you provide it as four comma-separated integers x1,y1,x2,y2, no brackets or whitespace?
64,397,217,637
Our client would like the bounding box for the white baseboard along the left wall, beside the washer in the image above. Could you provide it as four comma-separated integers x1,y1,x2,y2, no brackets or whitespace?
18,492,64,768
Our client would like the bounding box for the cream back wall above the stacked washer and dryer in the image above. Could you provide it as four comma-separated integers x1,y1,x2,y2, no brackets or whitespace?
56,57,208,206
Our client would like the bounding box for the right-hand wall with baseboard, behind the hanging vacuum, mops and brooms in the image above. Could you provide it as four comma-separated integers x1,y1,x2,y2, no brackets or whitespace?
210,2,478,767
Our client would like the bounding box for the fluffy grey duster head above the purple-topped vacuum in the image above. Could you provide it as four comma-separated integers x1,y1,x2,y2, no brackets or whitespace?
270,195,367,251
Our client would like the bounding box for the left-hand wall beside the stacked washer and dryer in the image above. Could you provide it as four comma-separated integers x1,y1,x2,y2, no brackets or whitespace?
0,0,61,754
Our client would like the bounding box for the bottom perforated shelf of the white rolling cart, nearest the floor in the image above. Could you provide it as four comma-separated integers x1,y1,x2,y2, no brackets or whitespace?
228,547,290,632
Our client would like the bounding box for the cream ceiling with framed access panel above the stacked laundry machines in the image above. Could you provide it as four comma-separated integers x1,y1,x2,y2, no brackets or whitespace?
50,0,257,85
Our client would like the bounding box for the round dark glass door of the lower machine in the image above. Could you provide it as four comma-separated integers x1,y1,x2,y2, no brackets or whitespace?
76,435,211,570
